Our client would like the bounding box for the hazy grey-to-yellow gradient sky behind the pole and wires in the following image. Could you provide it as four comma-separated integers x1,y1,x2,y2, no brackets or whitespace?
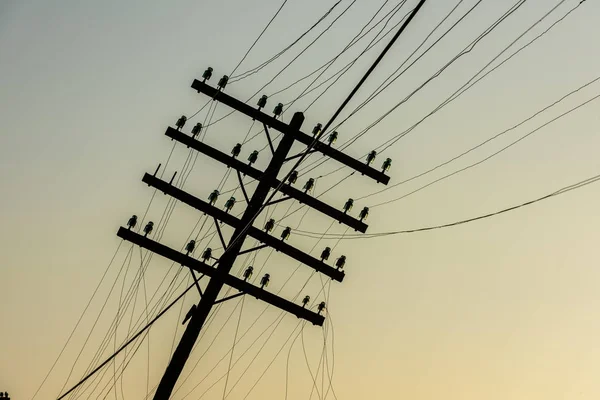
0,0,600,400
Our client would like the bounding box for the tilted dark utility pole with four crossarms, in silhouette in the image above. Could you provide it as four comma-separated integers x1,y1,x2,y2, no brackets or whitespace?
117,76,389,400
